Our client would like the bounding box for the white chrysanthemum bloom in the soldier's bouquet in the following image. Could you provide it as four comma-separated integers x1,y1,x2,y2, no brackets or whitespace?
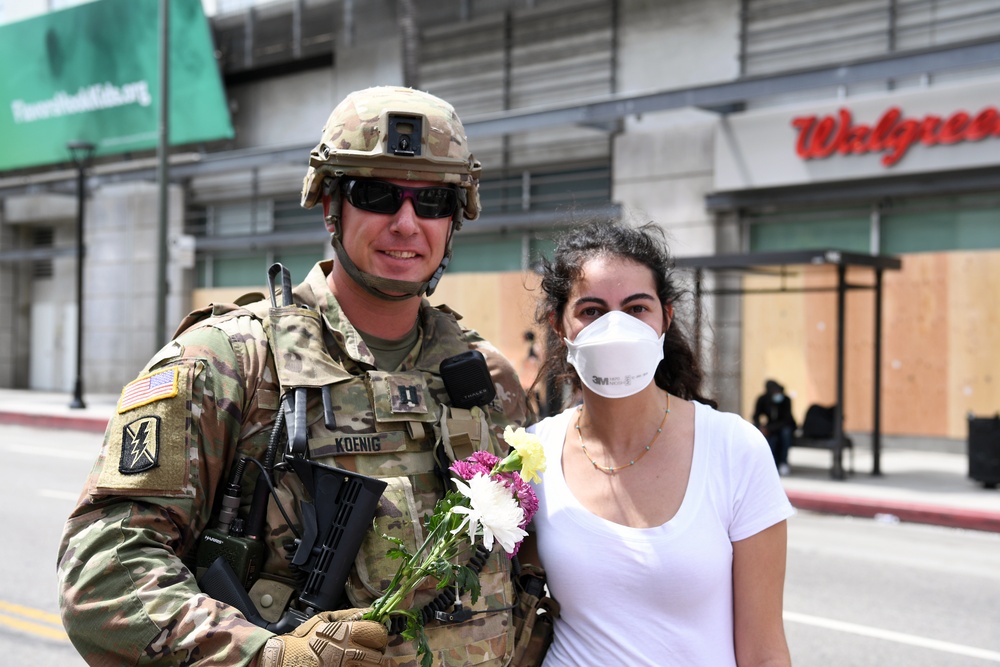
453,473,527,553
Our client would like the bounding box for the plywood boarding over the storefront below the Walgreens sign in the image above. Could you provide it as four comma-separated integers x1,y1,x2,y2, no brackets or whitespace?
742,251,1000,439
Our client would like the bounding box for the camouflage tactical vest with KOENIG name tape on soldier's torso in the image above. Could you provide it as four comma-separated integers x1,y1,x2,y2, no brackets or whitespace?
184,282,514,667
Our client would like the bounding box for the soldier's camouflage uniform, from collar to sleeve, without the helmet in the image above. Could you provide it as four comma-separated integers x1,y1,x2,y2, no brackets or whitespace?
59,263,526,666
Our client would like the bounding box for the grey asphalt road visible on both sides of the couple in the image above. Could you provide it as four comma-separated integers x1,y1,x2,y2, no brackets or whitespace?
0,426,1000,667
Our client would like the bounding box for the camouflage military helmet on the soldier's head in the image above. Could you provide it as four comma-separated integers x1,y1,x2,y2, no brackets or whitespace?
302,86,481,223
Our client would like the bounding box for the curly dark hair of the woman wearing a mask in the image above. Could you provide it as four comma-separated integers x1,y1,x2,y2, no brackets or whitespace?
535,220,716,407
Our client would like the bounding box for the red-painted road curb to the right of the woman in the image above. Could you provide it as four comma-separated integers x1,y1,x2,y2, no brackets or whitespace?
785,490,1000,533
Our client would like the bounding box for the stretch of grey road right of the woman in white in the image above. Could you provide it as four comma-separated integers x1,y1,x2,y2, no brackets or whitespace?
785,512,1000,667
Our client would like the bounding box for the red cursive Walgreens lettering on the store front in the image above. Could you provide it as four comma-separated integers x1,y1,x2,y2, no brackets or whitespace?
792,106,1000,167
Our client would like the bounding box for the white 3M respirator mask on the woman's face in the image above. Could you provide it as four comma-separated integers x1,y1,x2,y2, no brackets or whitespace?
563,310,665,398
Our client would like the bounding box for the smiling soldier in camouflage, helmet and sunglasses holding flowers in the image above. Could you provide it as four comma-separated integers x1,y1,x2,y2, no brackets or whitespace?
59,87,527,667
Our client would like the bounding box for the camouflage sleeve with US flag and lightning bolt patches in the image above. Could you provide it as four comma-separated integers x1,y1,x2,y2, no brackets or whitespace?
58,317,271,666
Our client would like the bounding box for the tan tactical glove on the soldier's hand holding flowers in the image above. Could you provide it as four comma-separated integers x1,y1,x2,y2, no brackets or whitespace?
260,609,389,667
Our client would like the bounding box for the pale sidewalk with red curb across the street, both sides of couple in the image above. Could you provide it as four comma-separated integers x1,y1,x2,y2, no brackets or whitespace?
0,389,1000,532
